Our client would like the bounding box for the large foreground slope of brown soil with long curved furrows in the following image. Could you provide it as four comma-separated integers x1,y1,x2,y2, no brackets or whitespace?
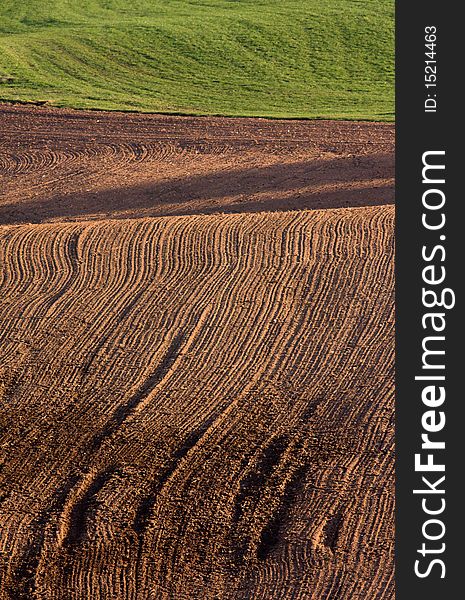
0,204,394,600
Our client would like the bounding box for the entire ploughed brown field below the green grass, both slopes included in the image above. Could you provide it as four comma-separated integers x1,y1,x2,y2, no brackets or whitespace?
0,106,394,600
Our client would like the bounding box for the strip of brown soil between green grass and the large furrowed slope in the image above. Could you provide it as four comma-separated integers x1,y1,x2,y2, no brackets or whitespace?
0,105,394,223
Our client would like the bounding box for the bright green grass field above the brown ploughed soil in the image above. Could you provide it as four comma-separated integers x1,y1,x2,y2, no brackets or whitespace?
0,0,394,120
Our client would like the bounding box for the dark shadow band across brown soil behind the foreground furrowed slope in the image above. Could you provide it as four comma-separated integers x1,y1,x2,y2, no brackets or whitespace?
0,154,394,224
